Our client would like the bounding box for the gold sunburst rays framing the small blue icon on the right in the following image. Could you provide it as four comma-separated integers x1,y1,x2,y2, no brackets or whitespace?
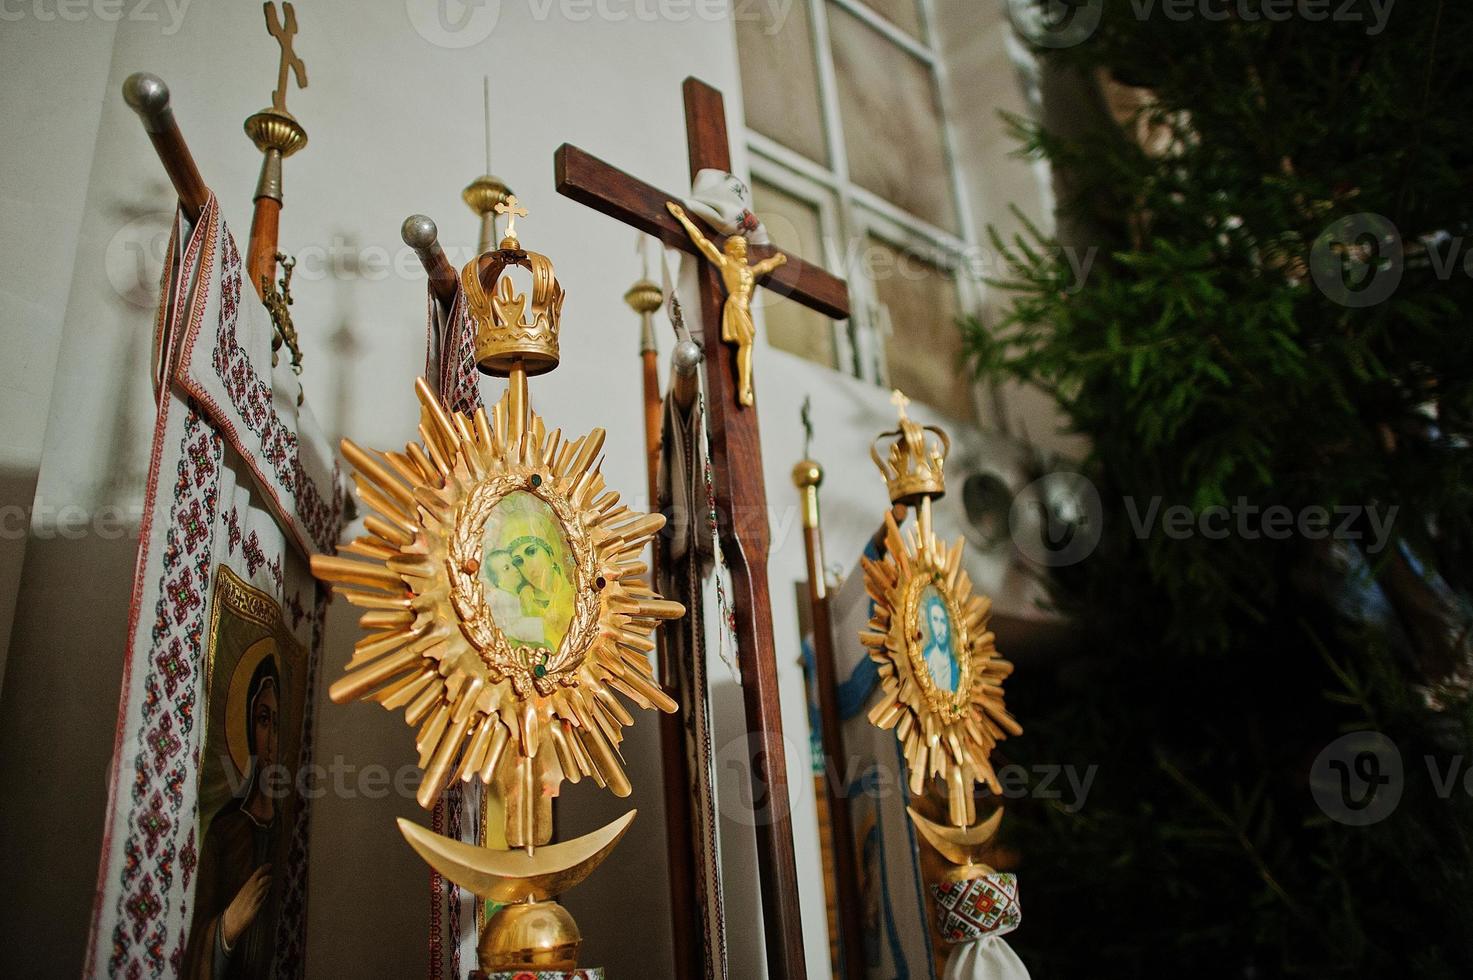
860,497,1022,827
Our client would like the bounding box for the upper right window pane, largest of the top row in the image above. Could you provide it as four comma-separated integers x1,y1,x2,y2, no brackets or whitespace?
828,3,956,231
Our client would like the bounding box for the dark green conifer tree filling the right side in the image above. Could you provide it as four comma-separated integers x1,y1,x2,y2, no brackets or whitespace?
962,0,1473,979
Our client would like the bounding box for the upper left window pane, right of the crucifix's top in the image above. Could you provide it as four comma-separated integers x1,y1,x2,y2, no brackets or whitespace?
732,3,828,165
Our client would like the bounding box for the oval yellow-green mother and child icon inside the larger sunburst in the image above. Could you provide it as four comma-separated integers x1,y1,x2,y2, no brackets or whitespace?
479,491,576,651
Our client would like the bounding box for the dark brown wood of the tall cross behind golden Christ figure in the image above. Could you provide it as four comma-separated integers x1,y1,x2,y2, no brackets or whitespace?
555,78,848,977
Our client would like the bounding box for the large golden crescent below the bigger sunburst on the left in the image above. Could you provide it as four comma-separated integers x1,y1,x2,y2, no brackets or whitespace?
399,811,638,903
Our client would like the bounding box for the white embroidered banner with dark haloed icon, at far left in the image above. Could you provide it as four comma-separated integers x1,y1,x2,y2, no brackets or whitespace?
85,197,345,977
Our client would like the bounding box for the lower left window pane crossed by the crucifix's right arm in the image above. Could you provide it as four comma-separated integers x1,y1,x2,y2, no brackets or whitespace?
751,180,837,367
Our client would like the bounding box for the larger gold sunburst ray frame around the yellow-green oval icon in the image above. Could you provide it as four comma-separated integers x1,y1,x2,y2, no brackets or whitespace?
312,374,685,808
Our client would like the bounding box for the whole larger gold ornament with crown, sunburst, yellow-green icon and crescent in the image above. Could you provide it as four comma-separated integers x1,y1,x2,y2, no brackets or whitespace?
312,197,685,973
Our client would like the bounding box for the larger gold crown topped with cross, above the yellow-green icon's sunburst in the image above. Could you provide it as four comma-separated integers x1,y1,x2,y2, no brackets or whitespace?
461,195,566,377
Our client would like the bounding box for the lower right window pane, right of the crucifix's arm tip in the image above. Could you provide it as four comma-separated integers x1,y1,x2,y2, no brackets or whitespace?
865,236,977,421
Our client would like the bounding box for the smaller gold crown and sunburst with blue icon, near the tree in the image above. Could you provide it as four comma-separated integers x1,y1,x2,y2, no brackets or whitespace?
860,391,1022,828
